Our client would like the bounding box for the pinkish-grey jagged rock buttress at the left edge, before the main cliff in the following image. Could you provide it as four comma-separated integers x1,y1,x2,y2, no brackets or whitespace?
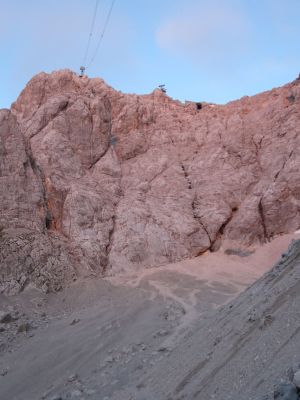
0,110,76,294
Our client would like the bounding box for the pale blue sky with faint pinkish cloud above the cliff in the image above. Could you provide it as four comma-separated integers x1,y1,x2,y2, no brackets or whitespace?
0,0,300,108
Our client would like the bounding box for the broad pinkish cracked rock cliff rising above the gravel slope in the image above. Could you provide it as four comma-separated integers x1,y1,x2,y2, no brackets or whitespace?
0,71,300,293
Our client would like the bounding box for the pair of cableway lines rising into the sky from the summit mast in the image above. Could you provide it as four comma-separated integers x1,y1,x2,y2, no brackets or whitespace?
79,0,116,77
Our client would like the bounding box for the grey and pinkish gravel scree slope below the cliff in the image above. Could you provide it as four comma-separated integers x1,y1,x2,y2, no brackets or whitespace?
0,235,300,400
